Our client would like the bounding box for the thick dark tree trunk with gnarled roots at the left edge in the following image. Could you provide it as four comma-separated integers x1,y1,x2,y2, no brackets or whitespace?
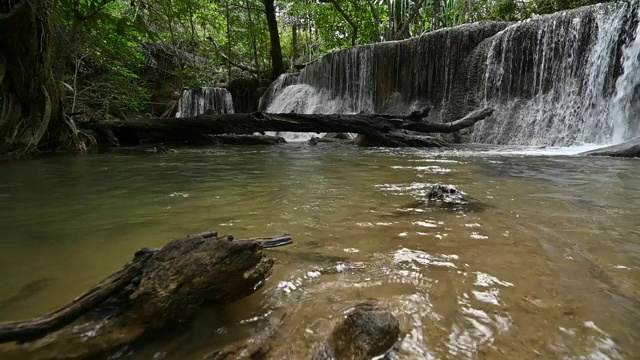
0,0,84,157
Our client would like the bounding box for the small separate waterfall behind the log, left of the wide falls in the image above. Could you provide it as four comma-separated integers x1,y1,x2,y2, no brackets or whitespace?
176,88,233,117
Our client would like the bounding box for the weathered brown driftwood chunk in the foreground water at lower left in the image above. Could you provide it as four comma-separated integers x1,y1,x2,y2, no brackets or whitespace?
0,231,292,358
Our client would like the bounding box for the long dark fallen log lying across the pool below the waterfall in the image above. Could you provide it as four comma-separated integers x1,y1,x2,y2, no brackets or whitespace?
78,108,493,147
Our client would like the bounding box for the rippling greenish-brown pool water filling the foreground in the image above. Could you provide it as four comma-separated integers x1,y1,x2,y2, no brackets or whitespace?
0,144,640,359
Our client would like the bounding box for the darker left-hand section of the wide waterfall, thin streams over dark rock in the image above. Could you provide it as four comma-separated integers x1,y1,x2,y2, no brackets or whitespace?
266,22,508,114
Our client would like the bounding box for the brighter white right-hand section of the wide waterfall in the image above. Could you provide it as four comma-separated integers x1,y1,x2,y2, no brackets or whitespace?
464,3,637,146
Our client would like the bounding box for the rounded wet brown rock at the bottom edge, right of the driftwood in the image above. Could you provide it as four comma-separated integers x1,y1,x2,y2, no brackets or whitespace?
311,302,400,360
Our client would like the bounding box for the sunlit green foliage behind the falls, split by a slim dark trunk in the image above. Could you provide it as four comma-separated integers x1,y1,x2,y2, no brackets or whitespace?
52,0,608,121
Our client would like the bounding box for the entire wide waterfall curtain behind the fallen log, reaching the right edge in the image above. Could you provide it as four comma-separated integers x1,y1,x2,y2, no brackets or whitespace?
265,0,640,146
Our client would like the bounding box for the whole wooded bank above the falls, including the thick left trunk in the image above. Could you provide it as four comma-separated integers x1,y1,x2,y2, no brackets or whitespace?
0,0,612,155
